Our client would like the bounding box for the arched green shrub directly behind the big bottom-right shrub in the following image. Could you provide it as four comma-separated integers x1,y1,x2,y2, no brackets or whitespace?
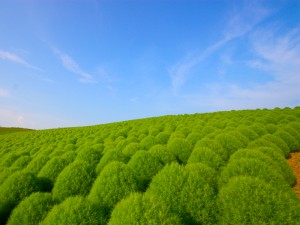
219,158,290,190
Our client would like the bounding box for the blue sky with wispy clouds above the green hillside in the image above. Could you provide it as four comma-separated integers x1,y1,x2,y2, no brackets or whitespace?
0,0,300,129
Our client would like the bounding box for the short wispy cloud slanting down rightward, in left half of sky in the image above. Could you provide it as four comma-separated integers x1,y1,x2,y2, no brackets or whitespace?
53,48,97,83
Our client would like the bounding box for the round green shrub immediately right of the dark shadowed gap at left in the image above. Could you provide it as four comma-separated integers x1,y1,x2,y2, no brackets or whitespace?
52,160,96,201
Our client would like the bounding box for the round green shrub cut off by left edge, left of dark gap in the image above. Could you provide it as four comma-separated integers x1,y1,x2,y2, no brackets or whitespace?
0,171,43,224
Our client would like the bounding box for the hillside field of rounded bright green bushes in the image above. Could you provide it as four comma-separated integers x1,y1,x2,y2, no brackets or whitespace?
0,107,300,225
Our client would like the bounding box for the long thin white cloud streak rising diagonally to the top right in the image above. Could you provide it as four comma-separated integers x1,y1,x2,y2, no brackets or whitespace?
168,1,270,93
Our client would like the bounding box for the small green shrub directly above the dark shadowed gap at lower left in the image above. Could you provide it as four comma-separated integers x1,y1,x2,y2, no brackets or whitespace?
38,157,69,184
